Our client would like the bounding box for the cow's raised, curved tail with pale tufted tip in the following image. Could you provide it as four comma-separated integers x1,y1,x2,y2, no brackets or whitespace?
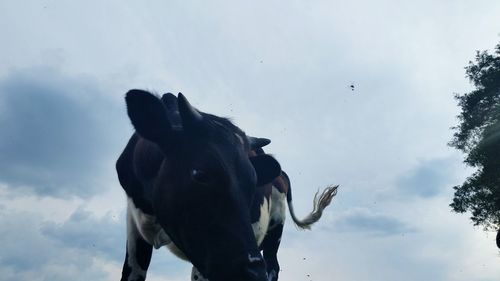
283,172,339,229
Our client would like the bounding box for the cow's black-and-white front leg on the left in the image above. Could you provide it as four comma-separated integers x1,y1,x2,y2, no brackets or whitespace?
121,208,153,281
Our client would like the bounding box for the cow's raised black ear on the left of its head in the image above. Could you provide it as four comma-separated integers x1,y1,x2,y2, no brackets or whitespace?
125,90,171,144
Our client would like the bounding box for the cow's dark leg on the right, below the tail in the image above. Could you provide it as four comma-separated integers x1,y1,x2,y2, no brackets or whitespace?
261,223,283,281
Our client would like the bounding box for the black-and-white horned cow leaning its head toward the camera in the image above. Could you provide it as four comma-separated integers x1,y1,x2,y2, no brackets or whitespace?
116,90,337,281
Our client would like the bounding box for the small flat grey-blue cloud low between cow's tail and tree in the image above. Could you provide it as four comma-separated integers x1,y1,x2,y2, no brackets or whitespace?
332,209,416,236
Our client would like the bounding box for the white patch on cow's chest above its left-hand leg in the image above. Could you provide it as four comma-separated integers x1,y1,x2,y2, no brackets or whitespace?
127,198,188,261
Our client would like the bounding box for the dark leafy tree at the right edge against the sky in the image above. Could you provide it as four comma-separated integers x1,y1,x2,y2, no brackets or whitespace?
449,44,500,243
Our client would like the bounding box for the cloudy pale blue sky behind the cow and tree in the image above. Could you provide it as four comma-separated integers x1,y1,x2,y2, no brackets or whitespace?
0,0,500,281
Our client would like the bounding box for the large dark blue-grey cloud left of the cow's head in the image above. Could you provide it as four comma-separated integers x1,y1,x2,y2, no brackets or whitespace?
0,66,131,198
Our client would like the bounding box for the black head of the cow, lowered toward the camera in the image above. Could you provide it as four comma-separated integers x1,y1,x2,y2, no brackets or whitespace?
126,90,281,281
